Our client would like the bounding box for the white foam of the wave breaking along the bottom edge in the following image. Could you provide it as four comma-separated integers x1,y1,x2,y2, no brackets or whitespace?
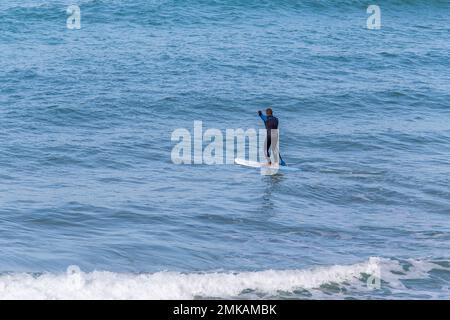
0,258,446,299
